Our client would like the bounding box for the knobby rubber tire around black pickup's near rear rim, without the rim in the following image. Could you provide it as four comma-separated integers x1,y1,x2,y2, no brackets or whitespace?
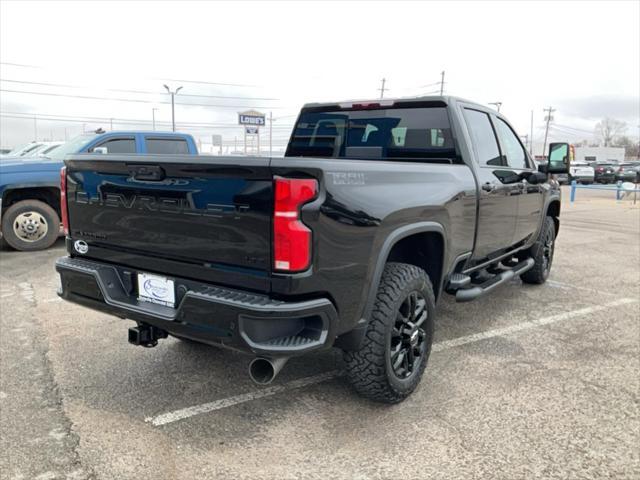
344,263,435,403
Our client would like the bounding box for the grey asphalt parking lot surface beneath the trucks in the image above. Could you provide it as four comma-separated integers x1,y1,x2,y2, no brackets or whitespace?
0,190,640,480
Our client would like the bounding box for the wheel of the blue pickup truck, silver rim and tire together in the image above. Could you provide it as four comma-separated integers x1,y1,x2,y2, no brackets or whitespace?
2,200,60,251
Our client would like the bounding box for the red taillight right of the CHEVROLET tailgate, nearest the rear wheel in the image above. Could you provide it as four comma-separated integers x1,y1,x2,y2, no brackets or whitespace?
273,177,318,272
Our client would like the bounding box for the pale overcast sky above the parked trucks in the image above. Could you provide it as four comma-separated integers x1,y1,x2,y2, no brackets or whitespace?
0,0,640,153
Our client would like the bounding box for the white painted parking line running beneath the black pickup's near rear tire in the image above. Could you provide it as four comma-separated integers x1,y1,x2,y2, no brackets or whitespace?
145,298,638,427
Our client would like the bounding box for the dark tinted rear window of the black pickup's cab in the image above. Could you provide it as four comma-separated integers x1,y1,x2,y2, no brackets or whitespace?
287,107,456,161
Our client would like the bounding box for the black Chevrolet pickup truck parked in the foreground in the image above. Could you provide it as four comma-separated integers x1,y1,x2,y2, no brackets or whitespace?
56,97,569,403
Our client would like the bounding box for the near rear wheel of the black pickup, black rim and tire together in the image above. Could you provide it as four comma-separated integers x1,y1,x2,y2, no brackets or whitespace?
344,263,435,403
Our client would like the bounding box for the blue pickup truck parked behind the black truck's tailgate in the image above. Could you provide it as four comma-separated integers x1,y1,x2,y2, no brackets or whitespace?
0,130,198,251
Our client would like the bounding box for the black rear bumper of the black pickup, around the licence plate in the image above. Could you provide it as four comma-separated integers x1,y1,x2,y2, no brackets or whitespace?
56,257,337,356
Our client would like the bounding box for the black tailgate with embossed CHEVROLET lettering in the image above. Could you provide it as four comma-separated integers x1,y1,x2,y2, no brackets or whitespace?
65,155,273,290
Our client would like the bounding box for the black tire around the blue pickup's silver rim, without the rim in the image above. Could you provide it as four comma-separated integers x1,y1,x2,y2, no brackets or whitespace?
2,200,60,252
